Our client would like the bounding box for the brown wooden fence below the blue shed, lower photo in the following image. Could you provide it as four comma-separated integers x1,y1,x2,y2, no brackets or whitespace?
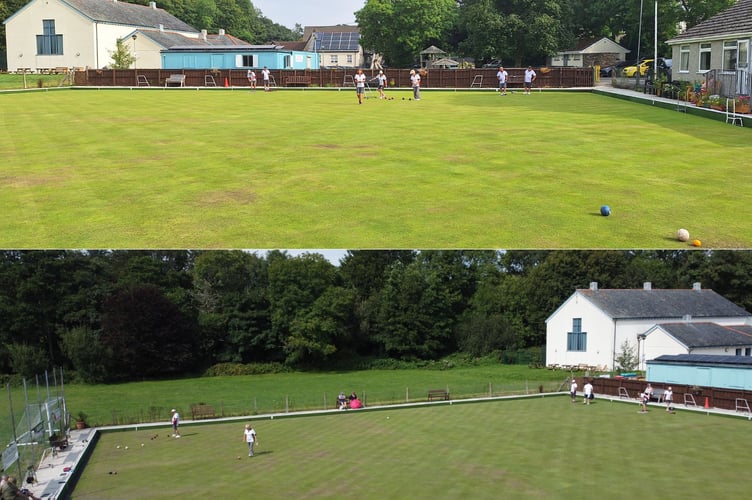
577,377,752,410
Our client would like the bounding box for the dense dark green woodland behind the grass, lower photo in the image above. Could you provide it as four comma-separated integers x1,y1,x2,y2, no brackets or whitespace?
0,250,752,382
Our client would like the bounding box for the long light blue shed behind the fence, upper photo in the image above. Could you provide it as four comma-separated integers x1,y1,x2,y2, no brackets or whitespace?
161,45,319,70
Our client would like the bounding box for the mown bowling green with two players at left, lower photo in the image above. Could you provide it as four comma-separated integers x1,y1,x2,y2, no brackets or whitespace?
72,397,750,500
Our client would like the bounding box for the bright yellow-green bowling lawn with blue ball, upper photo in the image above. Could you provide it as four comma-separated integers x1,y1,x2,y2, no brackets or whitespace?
0,89,752,249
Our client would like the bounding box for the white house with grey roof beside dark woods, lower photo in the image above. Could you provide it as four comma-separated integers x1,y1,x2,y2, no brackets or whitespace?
546,283,752,370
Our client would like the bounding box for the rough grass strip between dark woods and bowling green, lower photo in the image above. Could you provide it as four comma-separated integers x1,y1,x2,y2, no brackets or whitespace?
55,364,568,426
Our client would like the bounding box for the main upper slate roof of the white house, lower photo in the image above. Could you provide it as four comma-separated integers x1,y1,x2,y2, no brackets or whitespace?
577,288,752,319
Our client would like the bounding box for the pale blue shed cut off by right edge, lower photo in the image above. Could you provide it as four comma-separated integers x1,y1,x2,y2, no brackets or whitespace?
646,354,752,391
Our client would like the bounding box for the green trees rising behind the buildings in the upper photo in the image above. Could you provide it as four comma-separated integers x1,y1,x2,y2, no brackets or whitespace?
0,0,735,72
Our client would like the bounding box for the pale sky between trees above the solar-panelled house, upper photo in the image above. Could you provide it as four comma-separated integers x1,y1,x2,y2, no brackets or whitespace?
251,0,366,29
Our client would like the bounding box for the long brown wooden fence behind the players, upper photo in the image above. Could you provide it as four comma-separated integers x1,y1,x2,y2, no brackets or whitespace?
75,68,594,89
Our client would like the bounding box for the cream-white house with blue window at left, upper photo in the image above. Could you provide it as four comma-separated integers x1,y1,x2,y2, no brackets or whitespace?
4,0,201,71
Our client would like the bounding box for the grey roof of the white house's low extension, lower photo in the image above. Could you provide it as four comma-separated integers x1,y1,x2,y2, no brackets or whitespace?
648,322,752,349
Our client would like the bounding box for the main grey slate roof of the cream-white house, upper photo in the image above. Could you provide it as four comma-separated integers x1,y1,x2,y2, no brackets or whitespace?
60,0,198,33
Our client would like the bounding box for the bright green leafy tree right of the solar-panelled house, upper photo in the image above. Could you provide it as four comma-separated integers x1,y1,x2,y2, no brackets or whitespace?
355,0,458,67
